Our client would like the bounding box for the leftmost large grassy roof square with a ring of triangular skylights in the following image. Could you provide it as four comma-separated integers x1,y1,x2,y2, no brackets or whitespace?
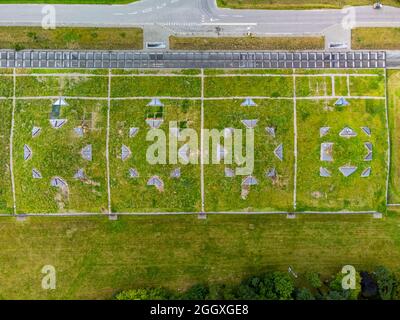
14,100,107,213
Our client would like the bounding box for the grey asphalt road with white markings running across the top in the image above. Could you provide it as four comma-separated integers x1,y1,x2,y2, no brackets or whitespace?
0,0,400,34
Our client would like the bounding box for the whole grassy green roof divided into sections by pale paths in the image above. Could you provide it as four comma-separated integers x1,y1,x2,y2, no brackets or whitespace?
0,69,390,213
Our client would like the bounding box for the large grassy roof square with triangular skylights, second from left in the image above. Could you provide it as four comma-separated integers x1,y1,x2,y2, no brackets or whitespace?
110,100,201,212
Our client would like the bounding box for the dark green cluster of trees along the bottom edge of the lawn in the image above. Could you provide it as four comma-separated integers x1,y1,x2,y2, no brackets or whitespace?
116,266,400,300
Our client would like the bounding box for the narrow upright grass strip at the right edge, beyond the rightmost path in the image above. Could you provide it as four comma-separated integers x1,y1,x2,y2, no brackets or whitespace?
388,70,400,203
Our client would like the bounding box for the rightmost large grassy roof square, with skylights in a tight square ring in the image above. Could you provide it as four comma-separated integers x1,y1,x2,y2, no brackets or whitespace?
297,99,387,211
